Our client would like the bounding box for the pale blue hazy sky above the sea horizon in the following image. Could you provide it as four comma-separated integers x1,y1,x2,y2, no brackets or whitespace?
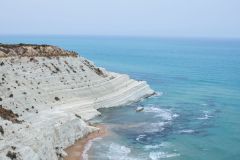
0,0,240,38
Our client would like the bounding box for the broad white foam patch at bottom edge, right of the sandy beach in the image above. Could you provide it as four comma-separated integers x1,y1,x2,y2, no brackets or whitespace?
107,143,137,160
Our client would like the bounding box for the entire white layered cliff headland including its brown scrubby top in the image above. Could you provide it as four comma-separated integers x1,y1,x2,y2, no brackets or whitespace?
0,44,154,160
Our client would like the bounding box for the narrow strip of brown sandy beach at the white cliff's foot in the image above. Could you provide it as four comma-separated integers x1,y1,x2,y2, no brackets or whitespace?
64,125,107,160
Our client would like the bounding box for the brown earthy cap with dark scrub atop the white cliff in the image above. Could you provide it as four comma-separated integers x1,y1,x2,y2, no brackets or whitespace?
0,43,78,58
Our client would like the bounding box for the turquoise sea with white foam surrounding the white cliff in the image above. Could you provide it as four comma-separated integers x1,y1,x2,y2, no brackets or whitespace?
0,36,240,160
